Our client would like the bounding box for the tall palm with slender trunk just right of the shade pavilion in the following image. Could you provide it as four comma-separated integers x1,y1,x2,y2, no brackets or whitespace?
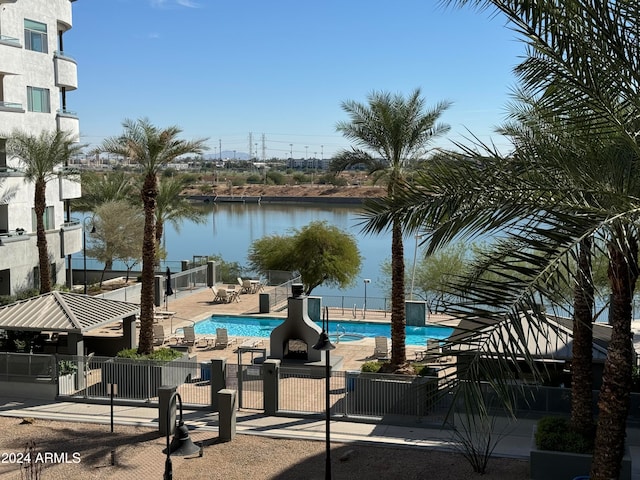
101,118,207,354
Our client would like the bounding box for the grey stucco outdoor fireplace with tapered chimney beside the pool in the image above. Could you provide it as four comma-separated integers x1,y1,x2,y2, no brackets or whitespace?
269,284,324,362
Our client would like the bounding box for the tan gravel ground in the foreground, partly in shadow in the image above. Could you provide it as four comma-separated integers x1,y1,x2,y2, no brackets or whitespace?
0,417,529,480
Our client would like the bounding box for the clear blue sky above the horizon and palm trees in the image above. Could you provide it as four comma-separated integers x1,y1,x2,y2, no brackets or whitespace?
65,0,524,158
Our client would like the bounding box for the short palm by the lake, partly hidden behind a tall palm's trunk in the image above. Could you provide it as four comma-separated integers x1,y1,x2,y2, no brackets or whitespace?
156,176,205,244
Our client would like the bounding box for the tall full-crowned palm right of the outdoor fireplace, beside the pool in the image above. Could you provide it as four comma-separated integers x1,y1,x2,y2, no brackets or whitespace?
332,89,450,370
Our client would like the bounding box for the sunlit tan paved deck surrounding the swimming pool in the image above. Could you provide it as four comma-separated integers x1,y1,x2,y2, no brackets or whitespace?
90,288,456,370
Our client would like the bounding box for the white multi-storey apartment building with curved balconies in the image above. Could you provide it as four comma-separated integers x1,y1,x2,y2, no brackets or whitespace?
0,0,83,295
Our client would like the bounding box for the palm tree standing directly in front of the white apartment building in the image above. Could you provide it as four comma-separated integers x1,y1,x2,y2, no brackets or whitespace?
7,130,83,293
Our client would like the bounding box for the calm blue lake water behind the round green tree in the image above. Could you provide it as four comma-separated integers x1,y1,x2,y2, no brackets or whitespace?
165,203,396,298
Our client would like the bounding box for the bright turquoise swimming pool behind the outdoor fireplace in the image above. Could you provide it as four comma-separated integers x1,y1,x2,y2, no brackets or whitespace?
195,315,453,345
